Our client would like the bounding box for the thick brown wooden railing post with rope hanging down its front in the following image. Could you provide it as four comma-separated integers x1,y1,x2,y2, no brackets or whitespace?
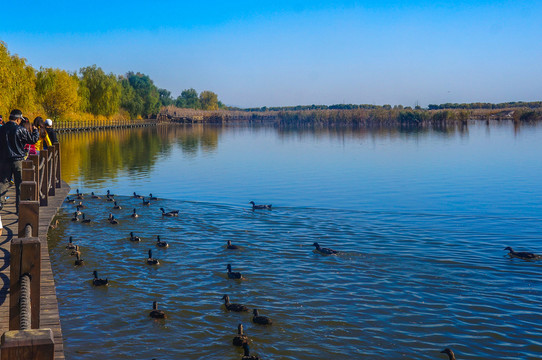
9,237,41,330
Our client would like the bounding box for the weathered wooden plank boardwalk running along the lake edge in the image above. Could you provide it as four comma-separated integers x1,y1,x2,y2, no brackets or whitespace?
0,182,70,360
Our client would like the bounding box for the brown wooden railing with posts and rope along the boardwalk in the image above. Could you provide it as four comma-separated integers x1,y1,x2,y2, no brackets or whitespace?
1,143,61,360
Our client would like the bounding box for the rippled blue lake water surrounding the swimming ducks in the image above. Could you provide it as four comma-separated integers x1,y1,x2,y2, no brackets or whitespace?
49,123,542,359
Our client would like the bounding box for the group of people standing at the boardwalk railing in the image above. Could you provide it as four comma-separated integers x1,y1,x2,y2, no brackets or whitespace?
0,109,58,235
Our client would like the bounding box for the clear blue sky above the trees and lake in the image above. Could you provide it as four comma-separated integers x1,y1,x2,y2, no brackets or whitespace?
0,0,542,107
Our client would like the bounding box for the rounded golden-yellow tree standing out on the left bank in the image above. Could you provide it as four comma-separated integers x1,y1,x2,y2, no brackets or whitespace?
36,68,80,119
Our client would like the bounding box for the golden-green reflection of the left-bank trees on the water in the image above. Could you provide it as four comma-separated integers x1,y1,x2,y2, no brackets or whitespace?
60,126,220,184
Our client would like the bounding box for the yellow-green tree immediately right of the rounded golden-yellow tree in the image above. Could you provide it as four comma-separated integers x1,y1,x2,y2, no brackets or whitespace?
79,65,121,116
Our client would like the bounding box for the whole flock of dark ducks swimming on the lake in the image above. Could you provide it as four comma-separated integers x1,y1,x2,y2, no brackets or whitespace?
58,189,542,360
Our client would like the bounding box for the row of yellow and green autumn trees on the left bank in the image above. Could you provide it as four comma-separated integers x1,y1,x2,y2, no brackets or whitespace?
0,41,225,120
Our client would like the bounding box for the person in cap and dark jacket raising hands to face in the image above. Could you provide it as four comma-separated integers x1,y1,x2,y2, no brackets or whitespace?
0,109,39,214
